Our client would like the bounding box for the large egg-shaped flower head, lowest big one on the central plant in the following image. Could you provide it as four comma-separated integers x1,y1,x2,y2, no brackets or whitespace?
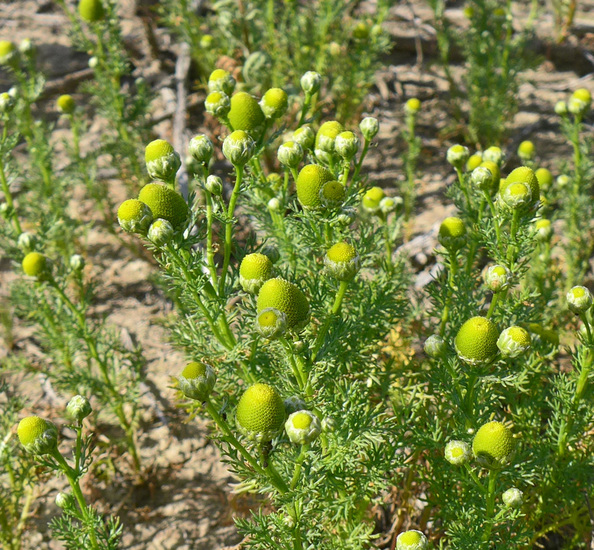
236,384,285,443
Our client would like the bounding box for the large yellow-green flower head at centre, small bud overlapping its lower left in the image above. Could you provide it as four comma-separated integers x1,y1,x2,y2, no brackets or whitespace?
256,277,309,330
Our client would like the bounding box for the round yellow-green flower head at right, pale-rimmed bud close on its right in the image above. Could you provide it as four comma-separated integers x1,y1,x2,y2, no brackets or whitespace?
454,317,499,365
